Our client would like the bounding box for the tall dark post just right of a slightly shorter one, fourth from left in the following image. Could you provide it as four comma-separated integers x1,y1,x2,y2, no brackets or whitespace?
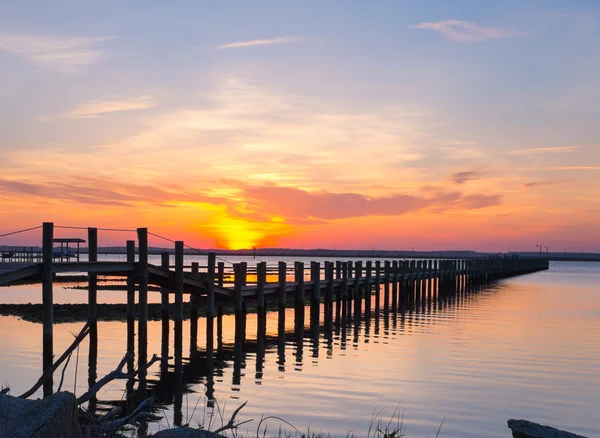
137,228,148,397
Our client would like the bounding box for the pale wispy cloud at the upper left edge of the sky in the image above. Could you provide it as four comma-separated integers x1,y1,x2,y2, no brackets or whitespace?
0,33,113,74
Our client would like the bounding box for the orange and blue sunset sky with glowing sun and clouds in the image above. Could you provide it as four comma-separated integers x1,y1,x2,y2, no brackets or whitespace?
0,0,600,252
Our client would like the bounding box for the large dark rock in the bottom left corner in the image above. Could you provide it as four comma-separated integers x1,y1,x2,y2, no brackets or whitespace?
0,392,79,438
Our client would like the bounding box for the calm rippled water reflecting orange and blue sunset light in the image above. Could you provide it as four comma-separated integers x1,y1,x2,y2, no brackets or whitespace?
0,257,600,437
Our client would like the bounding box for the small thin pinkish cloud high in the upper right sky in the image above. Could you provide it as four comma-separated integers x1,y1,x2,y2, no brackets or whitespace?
410,20,527,43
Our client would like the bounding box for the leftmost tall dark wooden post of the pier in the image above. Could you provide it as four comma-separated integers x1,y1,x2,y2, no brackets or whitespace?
42,222,54,397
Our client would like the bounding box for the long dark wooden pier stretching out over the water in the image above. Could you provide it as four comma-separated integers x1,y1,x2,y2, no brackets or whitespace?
0,223,548,396
